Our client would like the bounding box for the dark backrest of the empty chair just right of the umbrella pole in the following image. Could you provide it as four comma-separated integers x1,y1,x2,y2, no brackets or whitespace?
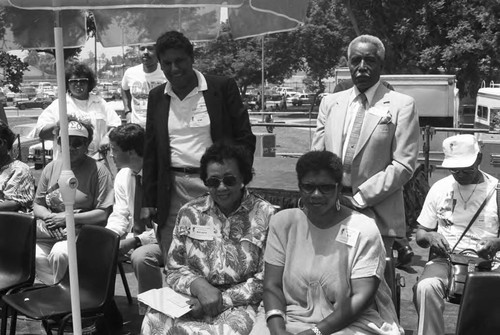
60,225,120,305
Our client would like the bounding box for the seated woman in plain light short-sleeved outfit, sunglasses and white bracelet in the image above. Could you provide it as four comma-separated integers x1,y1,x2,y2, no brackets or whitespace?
252,151,404,335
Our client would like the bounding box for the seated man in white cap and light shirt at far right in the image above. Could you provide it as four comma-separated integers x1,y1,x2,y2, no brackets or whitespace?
413,135,500,335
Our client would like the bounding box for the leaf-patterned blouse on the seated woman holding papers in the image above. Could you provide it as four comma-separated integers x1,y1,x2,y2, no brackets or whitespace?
166,191,274,307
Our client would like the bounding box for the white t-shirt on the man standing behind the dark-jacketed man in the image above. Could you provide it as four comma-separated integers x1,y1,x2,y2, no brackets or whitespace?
122,64,167,127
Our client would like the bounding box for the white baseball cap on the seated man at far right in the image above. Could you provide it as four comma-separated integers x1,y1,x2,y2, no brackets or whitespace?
442,134,480,169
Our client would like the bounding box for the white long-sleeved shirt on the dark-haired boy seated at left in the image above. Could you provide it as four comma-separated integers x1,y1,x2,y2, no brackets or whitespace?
106,168,158,245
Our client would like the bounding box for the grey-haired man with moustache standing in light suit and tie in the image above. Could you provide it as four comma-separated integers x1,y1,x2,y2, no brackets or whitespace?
312,35,419,251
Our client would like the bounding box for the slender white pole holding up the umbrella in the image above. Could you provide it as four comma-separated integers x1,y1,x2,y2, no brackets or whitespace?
54,11,82,335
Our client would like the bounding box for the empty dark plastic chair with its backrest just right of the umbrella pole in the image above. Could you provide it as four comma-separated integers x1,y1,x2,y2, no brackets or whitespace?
3,226,119,335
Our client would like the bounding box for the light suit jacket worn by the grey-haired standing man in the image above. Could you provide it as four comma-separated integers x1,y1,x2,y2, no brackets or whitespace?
312,85,419,237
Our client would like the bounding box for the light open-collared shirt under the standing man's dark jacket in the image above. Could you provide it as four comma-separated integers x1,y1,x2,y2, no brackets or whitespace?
165,70,213,168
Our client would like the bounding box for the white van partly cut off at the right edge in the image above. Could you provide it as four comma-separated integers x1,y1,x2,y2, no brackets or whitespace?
474,87,500,131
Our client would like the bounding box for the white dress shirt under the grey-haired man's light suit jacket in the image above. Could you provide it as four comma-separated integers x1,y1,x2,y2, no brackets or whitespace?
342,80,380,186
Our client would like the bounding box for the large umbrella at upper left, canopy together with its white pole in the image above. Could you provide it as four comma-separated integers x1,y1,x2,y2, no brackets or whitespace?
0,0,308,334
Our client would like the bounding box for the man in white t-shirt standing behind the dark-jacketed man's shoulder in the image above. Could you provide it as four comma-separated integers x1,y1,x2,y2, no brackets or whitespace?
122,44,166,128
